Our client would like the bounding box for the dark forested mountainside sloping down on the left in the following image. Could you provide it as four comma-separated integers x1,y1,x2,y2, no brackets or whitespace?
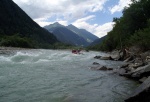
0,0,58,47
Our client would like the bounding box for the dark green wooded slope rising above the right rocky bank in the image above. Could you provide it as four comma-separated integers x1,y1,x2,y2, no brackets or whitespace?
89,0,150,51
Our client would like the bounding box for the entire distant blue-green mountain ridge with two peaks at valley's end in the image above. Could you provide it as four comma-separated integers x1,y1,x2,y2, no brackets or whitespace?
44,22,98,47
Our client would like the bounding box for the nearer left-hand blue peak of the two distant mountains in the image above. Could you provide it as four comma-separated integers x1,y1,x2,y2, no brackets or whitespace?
44,22,89,46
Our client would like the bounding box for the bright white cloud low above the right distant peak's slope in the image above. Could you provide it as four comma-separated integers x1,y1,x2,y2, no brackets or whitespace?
73,15,114,38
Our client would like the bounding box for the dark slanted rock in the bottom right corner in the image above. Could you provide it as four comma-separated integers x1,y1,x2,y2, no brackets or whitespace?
125,77,150,102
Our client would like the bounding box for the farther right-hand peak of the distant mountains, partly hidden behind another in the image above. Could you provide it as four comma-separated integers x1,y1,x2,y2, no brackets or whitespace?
67,24,98,43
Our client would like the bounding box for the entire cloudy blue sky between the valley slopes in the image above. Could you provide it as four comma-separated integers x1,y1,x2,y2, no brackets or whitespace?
13,0,131,38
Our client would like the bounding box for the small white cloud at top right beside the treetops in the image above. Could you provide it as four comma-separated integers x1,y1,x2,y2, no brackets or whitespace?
110,0,132,14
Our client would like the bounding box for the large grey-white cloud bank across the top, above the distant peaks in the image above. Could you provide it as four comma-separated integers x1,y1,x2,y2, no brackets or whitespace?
13,0,107,19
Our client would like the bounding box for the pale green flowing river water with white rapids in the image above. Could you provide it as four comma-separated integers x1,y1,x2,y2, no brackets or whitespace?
0,49,137,102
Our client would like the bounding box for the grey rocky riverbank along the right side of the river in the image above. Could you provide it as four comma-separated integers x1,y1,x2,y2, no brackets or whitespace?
92,47,150,102
